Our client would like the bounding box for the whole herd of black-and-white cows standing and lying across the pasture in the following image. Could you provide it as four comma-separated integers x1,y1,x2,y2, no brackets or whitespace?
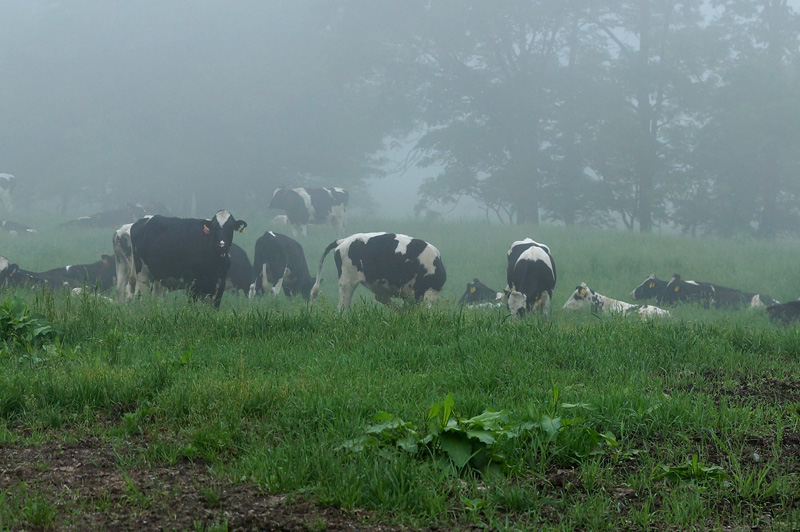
0,188,800,323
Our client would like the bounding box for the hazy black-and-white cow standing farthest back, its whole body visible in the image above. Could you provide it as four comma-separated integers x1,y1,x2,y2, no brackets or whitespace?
269,187,349,237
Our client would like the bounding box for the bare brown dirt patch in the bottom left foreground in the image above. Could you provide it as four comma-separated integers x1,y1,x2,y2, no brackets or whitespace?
0,438,400,531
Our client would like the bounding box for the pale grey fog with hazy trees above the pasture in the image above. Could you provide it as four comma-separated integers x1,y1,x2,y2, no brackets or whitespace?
0,0,800,237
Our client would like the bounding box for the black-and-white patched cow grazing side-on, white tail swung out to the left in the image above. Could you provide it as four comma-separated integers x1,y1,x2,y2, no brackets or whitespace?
311,233,447,311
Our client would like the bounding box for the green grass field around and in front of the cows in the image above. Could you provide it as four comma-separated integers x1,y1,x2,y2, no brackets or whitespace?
0,213,800,530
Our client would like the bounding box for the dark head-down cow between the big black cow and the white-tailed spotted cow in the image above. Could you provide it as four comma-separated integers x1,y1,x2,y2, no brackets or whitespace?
250,231,314,299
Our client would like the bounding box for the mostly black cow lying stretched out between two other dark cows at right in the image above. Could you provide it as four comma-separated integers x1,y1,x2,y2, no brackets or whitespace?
656,273,777,308
